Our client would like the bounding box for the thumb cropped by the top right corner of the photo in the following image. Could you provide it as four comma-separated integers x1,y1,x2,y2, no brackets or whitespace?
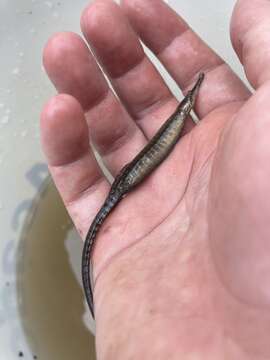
231,0,270,88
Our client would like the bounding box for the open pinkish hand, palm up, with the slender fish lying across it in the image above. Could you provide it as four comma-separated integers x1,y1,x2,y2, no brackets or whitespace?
41,0,270,360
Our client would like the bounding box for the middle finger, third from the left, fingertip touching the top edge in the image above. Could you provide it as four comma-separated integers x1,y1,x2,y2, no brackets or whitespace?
81,0,185,137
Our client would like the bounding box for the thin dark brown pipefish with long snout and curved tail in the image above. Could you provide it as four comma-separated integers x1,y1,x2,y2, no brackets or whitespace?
82,73,204,318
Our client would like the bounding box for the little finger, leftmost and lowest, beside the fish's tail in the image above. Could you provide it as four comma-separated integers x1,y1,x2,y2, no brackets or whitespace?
41,95,109,237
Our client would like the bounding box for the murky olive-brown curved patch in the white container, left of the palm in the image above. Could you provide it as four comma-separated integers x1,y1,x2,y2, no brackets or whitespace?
17,181,96,360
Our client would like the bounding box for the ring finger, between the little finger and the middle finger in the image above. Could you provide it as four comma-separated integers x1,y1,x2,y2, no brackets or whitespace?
44,33,145,174
